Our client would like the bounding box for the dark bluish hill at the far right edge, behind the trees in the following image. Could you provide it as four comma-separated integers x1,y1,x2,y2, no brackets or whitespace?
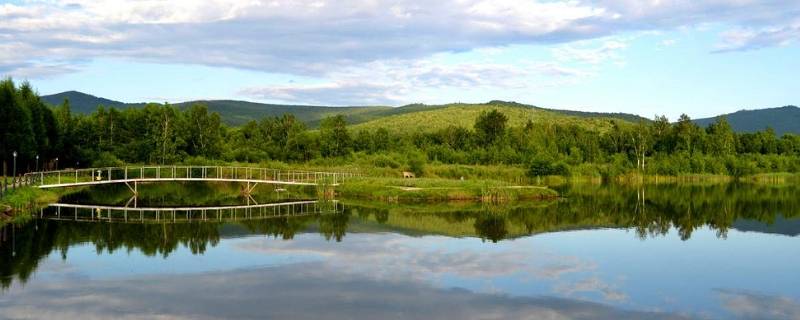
694,106,800,136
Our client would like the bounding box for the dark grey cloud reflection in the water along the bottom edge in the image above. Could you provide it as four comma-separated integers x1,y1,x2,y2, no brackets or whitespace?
0,263,686,320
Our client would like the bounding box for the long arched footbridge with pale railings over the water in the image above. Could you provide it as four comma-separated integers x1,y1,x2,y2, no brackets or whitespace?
23,166,356,194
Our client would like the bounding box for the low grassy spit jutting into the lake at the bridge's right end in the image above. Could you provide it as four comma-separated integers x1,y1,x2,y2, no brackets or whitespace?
336,178,558,202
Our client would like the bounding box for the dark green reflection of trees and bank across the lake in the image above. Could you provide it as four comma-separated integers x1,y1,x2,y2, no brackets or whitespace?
0,184,800,288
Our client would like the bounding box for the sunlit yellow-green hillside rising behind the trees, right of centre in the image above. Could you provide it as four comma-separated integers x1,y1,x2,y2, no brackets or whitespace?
352,102,619,132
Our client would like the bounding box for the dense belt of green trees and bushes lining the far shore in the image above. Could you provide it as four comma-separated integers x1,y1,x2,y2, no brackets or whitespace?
0,79,800,177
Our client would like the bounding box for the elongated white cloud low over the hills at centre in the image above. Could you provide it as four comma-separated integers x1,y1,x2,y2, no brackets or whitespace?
239,59,591,105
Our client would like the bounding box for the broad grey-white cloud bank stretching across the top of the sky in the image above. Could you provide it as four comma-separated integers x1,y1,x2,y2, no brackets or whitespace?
0,0,800,75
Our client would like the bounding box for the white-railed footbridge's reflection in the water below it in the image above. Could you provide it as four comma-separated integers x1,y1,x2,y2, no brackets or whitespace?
39,200,344,223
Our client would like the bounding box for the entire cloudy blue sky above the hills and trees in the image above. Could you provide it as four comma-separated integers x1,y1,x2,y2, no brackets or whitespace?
0,0,800,119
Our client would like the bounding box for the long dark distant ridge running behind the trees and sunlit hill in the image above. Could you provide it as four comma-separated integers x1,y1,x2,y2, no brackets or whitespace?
41,91,647,128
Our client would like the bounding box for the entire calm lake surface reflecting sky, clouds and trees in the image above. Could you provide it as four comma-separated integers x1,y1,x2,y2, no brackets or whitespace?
0,185,800,319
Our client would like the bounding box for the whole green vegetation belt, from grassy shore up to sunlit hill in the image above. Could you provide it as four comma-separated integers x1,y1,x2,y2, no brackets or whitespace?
0,79,800,218
